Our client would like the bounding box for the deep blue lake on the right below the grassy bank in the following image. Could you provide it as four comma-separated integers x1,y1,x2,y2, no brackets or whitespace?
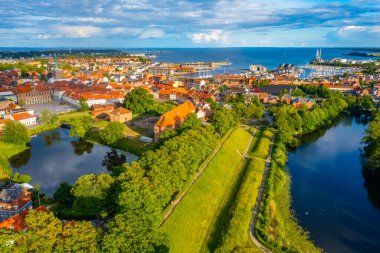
288,117,380,253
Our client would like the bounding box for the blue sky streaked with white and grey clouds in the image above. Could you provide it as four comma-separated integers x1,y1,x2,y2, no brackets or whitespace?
0,0,380,48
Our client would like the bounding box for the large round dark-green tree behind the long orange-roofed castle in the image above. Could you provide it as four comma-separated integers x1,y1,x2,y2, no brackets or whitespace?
124,88,155,113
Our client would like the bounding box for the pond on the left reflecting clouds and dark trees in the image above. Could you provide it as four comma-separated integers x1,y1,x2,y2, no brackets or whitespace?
10,128,137,196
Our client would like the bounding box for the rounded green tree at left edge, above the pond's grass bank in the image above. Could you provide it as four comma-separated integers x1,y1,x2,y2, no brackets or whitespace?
1,120,30,145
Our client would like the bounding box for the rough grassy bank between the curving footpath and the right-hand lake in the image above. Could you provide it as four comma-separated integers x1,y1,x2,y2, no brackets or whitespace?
255,143,322,253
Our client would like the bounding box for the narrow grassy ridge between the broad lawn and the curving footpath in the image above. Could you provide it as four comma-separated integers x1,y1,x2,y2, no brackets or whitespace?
214,129,273,253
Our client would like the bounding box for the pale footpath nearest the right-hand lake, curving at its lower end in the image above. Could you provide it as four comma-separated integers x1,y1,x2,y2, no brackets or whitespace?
250,135,275,253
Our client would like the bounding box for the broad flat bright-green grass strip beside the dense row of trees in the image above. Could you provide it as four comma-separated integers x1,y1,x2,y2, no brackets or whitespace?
161,128,251,253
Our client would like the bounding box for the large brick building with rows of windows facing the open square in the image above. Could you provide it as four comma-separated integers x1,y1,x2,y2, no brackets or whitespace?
17,85,51,105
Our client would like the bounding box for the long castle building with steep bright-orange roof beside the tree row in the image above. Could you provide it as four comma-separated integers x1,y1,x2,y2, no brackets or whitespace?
154,101,195,143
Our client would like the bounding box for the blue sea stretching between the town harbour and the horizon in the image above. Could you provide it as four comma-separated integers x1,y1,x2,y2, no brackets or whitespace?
0,47,380,73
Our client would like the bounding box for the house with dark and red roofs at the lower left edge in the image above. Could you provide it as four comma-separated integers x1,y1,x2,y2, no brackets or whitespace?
0,183,32,222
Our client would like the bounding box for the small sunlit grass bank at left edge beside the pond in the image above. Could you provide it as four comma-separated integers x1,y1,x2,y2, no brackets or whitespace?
0,142,28,180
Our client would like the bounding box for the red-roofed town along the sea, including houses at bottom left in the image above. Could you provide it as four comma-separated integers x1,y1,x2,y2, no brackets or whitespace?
0,50,380,251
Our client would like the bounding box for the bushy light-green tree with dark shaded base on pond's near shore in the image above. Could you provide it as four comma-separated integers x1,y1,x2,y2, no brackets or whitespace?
71,174,115,216
